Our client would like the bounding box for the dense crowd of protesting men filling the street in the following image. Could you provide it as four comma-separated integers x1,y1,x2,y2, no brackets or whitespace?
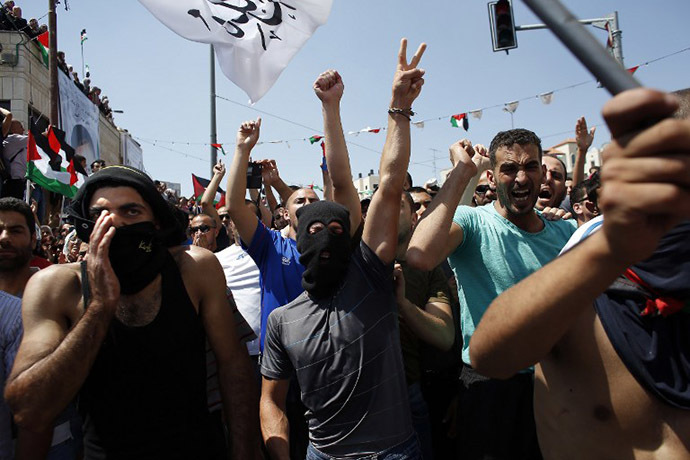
0,40,690,460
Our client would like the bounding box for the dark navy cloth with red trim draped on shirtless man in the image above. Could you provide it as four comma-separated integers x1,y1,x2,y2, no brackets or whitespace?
594,222,690,409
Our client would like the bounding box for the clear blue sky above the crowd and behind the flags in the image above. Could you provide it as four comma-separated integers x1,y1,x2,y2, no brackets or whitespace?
35,0,690,195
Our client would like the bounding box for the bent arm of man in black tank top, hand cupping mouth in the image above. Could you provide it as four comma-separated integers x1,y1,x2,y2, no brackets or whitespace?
5,211,120,432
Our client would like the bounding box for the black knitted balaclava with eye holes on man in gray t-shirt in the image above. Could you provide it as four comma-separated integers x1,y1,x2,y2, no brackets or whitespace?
297,201,351,299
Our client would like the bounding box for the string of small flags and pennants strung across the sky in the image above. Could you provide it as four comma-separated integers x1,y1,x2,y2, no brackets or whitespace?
139,47,690,148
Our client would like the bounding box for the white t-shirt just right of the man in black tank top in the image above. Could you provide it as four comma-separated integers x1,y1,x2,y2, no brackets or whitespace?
215,244,261,355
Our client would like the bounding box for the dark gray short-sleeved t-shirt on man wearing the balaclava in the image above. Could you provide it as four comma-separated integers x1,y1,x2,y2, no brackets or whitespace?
261,242,413,457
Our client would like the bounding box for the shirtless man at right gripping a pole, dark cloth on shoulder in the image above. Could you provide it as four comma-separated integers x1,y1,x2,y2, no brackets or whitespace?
470,89,690,460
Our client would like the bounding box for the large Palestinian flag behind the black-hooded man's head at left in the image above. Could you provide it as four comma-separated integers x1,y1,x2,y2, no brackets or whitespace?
26,123,86,198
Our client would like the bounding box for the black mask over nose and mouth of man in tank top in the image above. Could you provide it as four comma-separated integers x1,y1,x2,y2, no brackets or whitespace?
109,222,167,294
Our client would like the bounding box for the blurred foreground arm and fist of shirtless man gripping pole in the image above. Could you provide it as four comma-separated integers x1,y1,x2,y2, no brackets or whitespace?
470,89,690,378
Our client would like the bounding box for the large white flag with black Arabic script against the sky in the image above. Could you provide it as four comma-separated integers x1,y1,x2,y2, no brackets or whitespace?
139,0,333,103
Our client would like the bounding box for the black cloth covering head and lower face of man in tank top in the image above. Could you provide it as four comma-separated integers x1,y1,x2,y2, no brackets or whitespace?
67,165,186,294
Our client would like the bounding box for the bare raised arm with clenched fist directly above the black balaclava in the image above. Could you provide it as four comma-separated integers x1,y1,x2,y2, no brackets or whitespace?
314,70,362,235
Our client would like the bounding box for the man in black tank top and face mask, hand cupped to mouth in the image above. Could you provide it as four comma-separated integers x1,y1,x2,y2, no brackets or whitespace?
6,166,261,459
